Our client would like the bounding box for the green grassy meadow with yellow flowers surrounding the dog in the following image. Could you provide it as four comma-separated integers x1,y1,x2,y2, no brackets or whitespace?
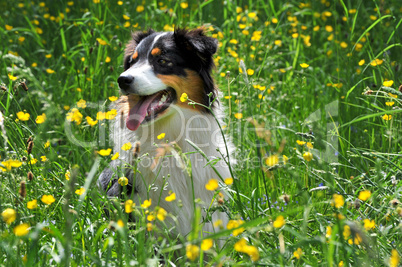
0,0,402,266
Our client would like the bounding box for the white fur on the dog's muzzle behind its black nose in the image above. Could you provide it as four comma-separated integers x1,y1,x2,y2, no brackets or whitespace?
121,61,166,95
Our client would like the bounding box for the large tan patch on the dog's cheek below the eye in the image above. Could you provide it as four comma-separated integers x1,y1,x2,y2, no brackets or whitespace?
157,70,205,111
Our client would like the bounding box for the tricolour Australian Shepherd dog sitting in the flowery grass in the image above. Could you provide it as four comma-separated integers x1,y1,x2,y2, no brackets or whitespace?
98,29,231,246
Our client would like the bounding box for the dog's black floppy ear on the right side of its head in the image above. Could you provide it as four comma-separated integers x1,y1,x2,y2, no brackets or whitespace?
173,28,218,58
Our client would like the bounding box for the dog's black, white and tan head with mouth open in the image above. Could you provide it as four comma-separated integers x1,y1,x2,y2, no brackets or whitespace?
117,29,218,131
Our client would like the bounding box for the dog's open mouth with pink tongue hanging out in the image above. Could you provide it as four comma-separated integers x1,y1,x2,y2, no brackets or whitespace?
126,88,176,131
